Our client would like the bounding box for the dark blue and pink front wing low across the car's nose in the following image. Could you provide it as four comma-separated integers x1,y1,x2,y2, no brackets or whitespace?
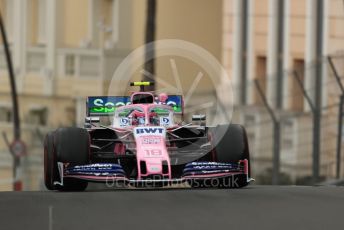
54,159,253,186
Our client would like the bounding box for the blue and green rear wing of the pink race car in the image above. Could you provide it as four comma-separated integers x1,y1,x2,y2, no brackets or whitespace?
86,95,184,117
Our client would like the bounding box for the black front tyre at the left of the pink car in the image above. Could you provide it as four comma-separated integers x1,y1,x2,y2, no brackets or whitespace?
44,128,90,191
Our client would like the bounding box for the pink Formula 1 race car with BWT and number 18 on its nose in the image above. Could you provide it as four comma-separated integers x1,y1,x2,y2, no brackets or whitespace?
44,82,251,191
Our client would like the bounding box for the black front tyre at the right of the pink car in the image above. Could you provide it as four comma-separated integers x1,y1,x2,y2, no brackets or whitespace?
213,124,250,187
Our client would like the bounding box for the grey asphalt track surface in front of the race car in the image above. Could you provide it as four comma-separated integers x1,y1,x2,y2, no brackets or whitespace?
0,186,344,230
